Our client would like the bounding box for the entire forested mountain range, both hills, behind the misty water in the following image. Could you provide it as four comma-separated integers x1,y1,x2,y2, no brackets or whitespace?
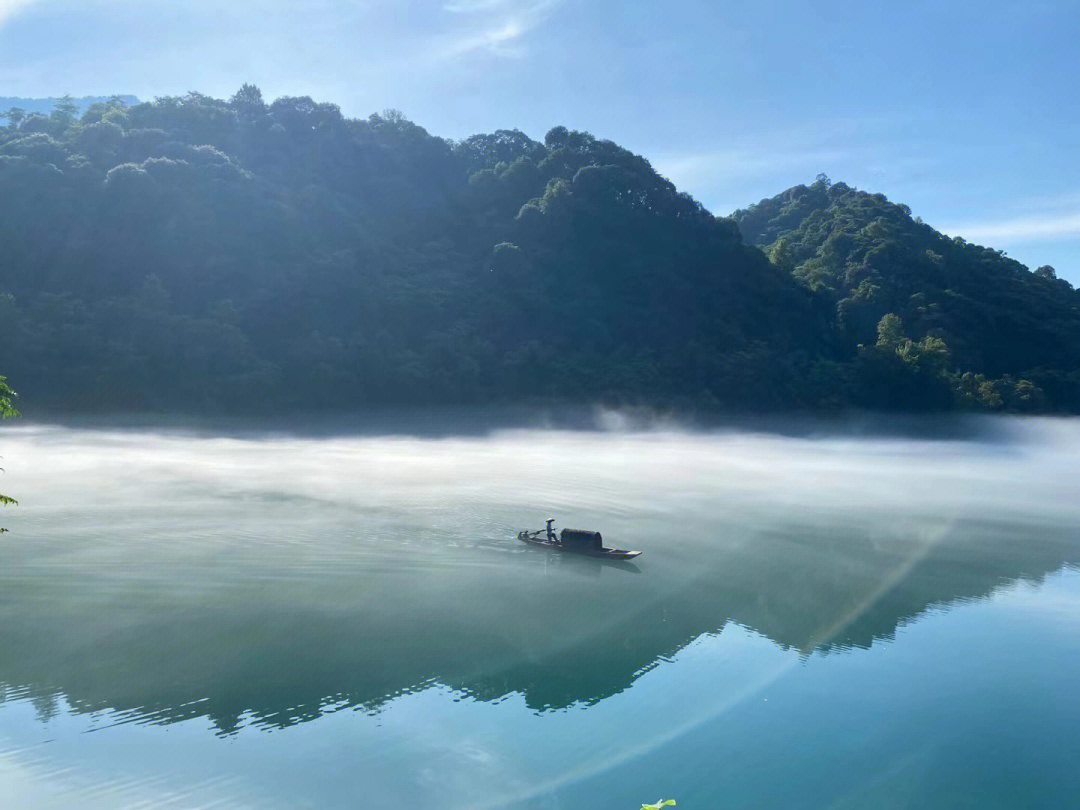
0,85,1080,411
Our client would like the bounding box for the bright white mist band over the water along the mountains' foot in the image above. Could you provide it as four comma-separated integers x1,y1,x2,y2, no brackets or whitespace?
8,411,1080,522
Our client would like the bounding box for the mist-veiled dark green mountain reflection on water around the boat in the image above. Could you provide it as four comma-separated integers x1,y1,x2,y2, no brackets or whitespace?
0,420,1080,732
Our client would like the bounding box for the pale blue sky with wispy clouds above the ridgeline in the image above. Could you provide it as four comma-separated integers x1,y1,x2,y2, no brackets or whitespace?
0,0,1080,284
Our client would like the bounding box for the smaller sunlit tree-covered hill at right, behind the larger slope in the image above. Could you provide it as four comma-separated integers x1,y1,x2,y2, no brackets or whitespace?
734,177,1080,409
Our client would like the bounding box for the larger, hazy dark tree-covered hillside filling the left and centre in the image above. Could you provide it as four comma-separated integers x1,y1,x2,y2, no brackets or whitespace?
0,86,813,409
